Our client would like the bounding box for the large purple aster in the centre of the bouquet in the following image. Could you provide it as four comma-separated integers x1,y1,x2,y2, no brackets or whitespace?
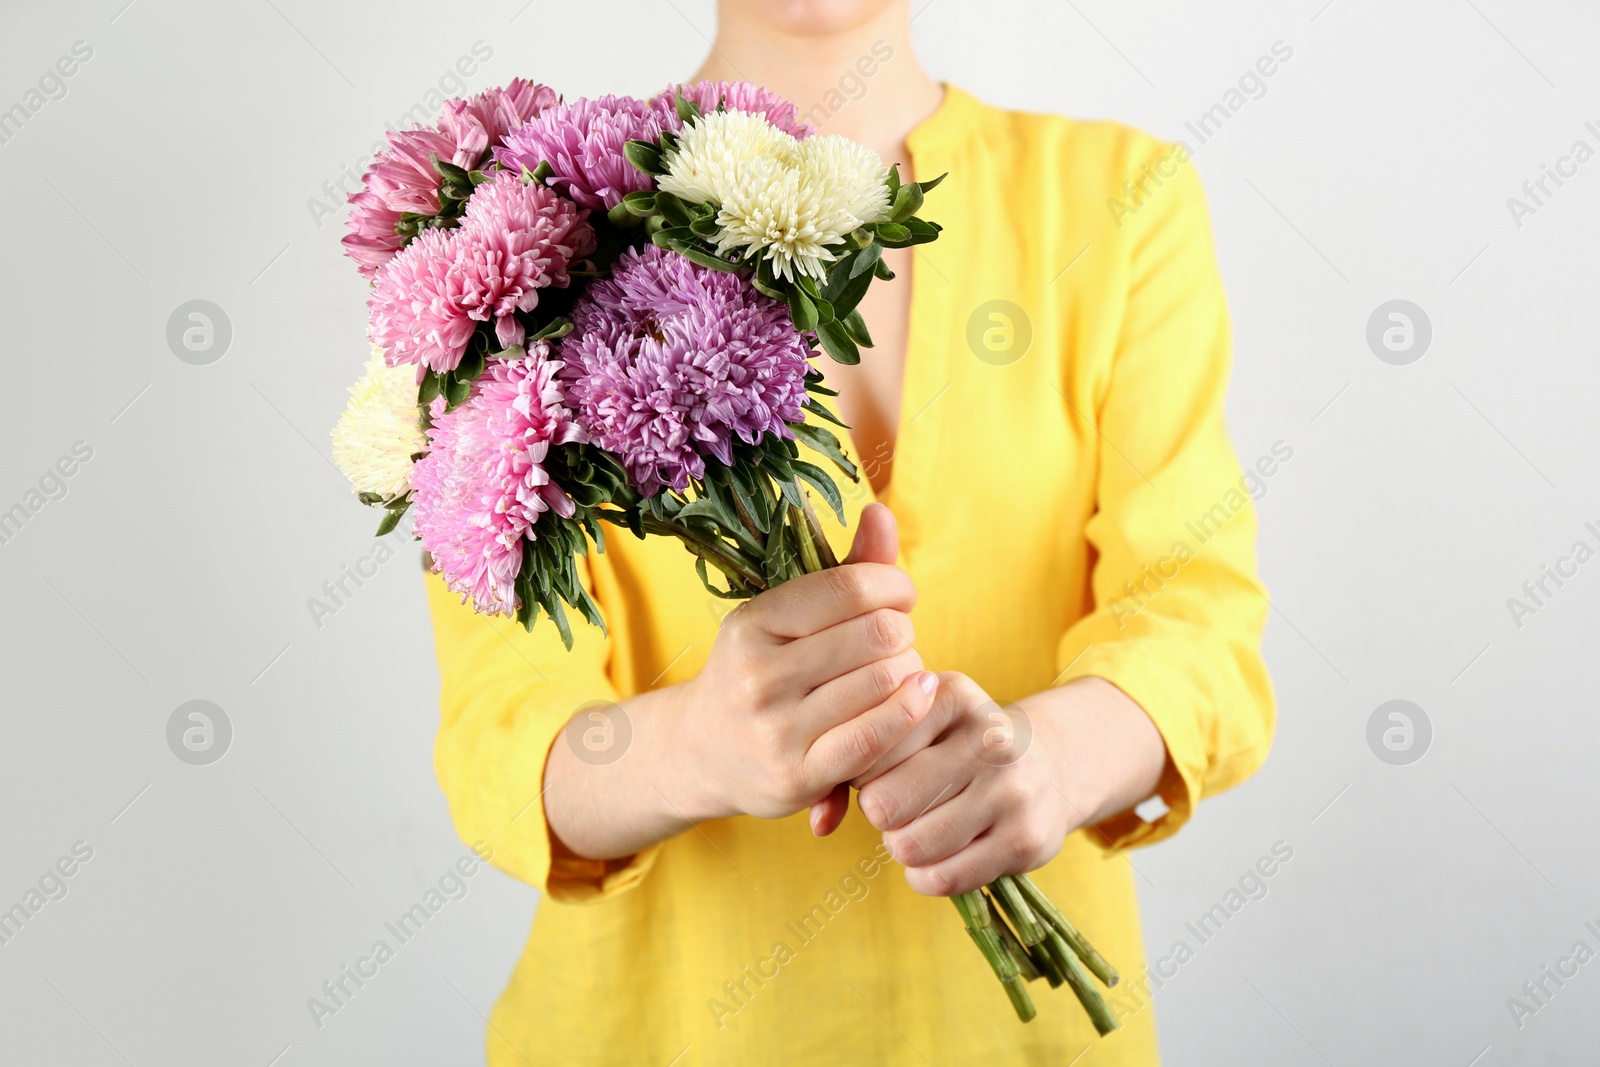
562,245,810,496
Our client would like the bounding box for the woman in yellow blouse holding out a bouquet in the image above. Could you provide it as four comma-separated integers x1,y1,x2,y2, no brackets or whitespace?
429,0,1274,1067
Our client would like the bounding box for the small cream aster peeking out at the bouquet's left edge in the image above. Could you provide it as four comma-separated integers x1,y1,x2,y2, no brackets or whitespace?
333,346,427,499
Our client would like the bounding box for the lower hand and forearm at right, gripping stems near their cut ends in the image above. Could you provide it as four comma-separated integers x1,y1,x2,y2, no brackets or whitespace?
853,673,1166,896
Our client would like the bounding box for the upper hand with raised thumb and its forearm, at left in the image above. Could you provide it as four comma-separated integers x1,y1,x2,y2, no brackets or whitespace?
544,506,938,859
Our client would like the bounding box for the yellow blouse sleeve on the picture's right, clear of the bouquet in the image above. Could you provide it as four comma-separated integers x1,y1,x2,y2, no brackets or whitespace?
1056,150,1275,848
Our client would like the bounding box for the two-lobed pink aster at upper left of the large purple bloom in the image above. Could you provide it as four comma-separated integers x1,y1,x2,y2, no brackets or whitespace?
366,171,595,371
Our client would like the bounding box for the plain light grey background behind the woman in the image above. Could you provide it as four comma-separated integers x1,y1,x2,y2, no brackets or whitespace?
0,0,1600,1067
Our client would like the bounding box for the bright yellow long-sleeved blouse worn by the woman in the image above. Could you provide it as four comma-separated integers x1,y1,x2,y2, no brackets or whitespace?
427,88,1274,1067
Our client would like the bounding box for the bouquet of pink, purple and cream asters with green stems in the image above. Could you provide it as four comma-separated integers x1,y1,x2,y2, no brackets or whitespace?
333,80,1117,1033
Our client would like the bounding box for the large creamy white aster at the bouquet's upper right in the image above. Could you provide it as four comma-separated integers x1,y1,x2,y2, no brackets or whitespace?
658,110,890,280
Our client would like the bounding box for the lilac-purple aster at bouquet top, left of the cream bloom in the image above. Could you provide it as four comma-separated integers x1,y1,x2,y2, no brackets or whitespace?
494,96,677,211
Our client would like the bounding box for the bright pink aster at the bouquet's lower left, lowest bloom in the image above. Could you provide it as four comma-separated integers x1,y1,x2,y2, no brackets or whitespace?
411,348,582,614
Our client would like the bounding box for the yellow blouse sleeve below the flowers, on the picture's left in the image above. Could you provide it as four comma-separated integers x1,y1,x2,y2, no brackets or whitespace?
426,563,659,902
